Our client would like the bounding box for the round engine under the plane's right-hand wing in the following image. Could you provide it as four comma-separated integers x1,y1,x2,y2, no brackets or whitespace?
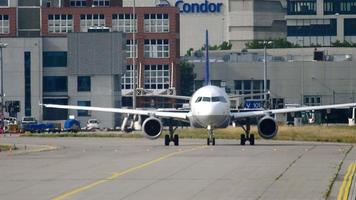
257,116,278,139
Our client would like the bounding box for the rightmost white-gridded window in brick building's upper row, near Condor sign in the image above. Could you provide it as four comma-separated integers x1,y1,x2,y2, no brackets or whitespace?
144,14,169,33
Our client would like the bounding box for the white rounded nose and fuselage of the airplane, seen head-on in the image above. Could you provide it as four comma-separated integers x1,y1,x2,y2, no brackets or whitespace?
190,85,230,128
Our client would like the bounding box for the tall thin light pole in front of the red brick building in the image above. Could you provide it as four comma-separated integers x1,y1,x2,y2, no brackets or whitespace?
132,0,138,109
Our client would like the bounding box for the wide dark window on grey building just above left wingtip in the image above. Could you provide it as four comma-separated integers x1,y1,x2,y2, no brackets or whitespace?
43,76,68,92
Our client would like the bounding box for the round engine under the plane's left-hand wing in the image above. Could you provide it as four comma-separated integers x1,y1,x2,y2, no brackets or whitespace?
142,117,163,140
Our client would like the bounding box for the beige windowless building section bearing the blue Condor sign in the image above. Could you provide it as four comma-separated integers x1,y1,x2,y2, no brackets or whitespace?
123,0,287,56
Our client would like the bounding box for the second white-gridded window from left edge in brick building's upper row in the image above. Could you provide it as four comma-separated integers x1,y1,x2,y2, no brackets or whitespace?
48,14,73,33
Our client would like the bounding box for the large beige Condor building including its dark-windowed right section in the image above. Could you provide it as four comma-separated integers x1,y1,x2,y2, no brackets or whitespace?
123,0,356,56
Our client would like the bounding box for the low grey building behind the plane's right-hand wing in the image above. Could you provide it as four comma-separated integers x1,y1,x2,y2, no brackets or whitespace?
184,48,356,120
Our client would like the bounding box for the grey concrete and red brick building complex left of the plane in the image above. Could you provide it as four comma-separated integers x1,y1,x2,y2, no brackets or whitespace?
0,0,180,128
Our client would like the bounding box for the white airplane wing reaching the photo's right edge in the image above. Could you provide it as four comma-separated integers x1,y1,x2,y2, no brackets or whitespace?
231,103,356,118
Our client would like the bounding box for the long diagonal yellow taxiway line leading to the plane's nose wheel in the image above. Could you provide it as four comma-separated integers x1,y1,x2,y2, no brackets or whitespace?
52,145,207,200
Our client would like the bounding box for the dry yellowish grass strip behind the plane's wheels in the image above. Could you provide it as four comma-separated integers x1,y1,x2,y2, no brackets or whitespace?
23,125,356,143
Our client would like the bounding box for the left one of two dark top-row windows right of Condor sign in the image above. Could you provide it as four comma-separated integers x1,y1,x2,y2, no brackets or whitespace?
287,0,316,15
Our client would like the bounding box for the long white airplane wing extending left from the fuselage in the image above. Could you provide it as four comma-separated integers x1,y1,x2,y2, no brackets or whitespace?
40,104,189,120
